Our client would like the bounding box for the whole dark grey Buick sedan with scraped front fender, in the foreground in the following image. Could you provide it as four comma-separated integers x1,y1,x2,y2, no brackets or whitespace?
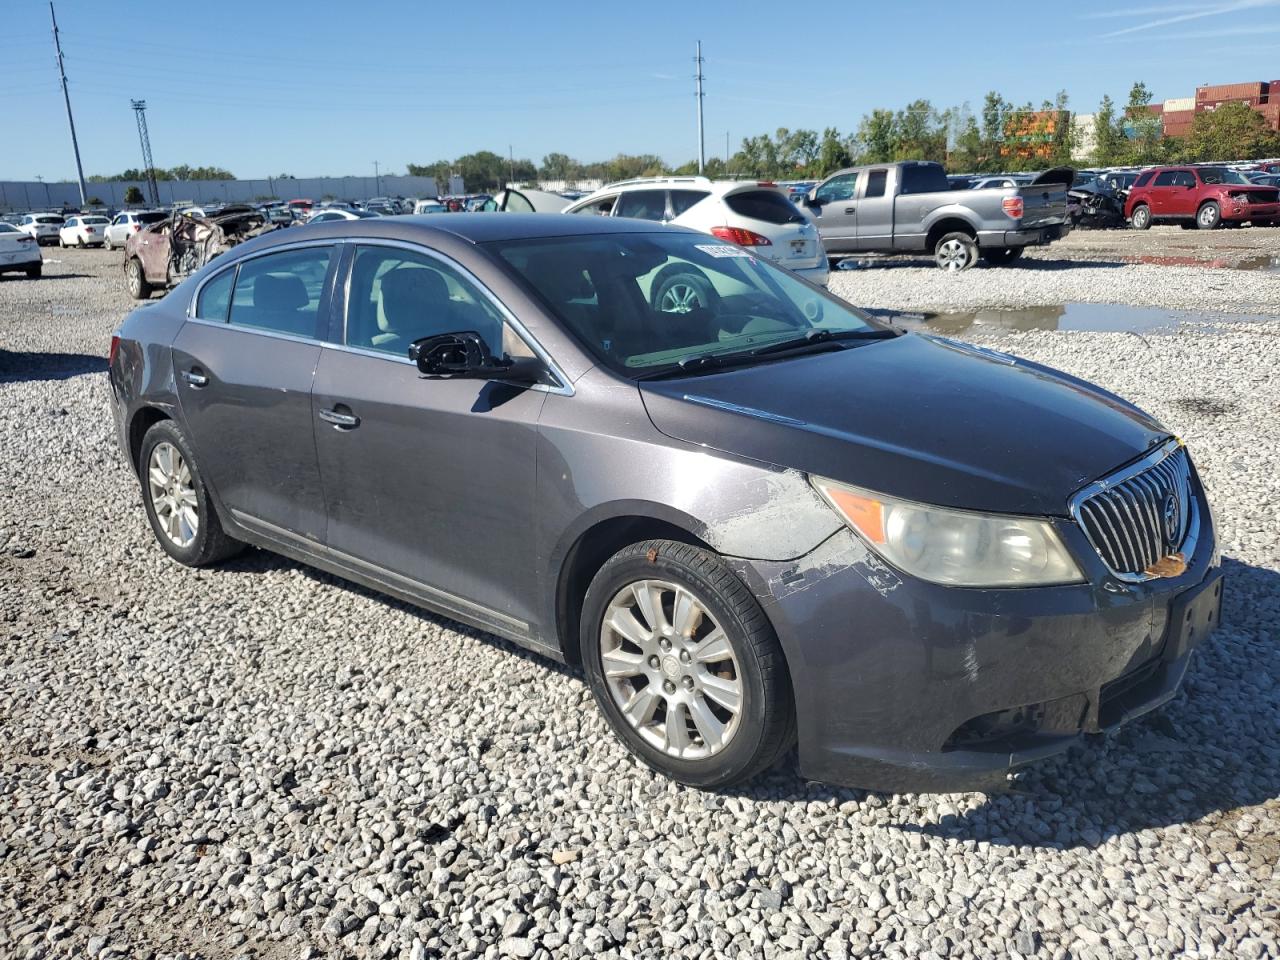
110,214,1222,791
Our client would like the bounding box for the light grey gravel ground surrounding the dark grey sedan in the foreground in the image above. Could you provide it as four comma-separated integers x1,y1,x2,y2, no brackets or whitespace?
0,252,1280,960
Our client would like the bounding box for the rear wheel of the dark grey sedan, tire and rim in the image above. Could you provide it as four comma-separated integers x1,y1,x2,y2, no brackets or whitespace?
138,420,244,567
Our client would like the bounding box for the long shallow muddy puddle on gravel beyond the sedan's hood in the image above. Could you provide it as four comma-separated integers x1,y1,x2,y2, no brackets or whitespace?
867,303,1276,343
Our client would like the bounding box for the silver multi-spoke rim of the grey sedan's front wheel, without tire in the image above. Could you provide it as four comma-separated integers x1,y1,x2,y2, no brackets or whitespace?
600,580,744,760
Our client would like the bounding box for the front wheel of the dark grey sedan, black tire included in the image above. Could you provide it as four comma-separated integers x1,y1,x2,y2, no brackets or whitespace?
581,540,795,788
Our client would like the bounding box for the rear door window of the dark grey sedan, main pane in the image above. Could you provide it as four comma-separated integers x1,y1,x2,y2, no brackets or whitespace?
230,247,333,337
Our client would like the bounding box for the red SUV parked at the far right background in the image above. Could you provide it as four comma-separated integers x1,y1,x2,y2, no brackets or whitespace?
1124,166,1280,230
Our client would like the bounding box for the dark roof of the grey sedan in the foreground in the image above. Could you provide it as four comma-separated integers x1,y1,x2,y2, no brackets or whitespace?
255,212,700,250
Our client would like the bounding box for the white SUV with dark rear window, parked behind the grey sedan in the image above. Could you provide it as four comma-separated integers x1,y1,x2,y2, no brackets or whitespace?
564,177,829,289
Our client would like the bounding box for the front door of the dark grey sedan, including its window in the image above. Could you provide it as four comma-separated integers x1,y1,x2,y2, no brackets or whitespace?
312,243,547,634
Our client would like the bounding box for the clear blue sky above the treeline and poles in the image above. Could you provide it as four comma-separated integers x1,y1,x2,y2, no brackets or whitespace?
0,0,1280,180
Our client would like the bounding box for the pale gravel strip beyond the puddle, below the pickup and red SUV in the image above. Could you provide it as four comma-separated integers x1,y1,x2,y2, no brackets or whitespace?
831,227,1280,315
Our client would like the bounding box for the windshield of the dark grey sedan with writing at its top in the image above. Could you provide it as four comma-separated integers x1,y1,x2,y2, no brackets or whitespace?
486,232,892,379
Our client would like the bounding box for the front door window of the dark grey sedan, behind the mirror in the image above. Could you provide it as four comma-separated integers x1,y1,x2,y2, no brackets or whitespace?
347,246,522,357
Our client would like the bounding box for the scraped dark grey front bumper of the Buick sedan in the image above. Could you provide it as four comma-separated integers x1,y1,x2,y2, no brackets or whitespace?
736,509,1221,792
